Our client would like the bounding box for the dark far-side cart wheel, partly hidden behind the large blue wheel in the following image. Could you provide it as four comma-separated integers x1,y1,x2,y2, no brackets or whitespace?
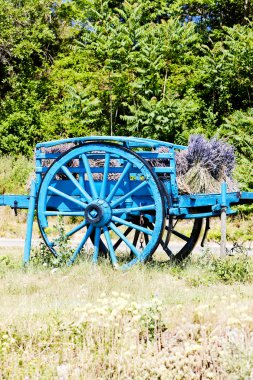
132,218,203,262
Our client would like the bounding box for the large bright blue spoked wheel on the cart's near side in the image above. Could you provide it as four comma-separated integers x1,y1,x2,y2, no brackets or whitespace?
38,142,165,269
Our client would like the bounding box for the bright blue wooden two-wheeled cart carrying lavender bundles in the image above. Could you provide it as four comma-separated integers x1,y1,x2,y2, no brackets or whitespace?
0,136,253,269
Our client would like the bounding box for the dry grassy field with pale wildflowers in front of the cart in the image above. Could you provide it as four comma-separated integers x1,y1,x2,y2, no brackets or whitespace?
0,248,253,380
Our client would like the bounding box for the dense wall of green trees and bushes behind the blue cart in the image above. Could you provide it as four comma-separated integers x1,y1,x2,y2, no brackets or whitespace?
0,0,253,189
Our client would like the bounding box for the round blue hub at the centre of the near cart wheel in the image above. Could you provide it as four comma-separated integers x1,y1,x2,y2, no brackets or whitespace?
85,199,112,227
